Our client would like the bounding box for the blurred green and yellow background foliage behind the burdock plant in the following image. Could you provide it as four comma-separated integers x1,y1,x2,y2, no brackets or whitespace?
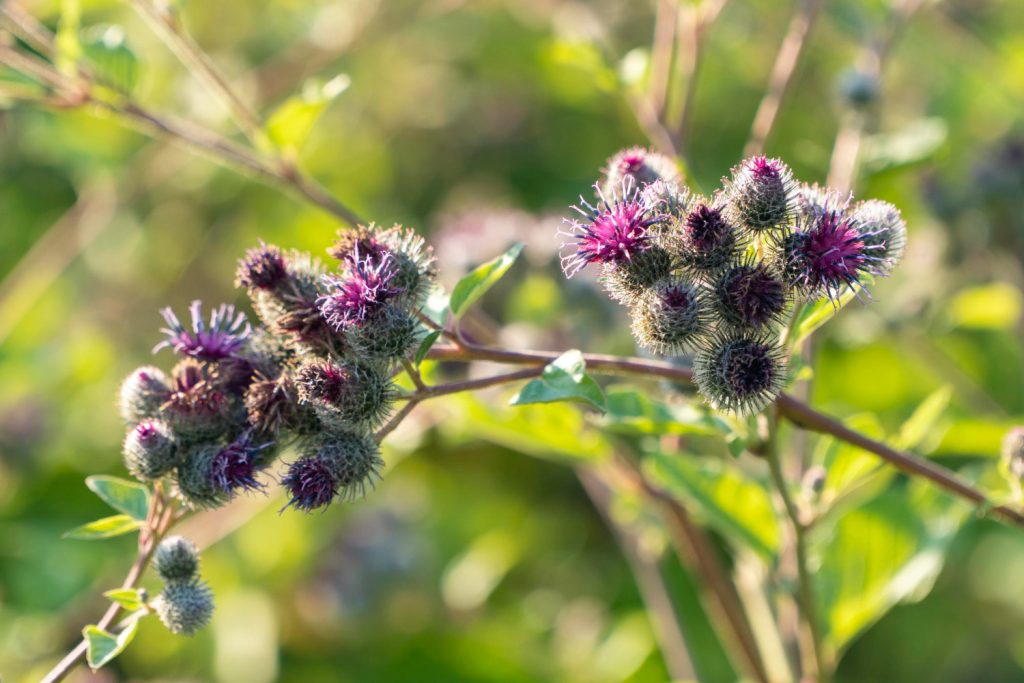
0,0,1024,683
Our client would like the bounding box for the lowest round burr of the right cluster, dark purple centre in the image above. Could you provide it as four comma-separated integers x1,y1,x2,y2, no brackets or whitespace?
693,334,785,415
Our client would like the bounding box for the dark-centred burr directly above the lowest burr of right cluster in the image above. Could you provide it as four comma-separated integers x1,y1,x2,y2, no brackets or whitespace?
711,260,787,330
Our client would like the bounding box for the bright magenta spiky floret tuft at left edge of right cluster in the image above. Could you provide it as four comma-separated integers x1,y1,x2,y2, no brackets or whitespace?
559,181,665,278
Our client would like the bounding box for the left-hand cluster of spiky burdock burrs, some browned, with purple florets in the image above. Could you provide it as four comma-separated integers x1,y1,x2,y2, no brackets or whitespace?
120,225,436,511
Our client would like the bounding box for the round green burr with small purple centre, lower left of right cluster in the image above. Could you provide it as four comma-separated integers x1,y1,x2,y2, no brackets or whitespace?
630,280,707,355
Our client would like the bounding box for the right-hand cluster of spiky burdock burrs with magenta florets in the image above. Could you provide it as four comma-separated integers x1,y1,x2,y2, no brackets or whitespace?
560,147,906,414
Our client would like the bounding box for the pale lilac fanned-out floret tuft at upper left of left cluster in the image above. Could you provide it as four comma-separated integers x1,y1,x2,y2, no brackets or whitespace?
153,299,250,360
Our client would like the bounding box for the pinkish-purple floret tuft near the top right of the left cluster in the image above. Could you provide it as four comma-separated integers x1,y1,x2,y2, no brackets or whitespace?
316,254,400,332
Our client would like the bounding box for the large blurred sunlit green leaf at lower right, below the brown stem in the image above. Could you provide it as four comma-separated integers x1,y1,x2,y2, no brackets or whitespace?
813,481,970,651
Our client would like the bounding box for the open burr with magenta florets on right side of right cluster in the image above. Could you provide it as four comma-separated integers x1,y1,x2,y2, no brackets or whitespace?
781,200,884,300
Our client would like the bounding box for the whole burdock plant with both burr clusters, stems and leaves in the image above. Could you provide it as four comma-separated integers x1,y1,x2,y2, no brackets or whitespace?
14,0,1024,683
